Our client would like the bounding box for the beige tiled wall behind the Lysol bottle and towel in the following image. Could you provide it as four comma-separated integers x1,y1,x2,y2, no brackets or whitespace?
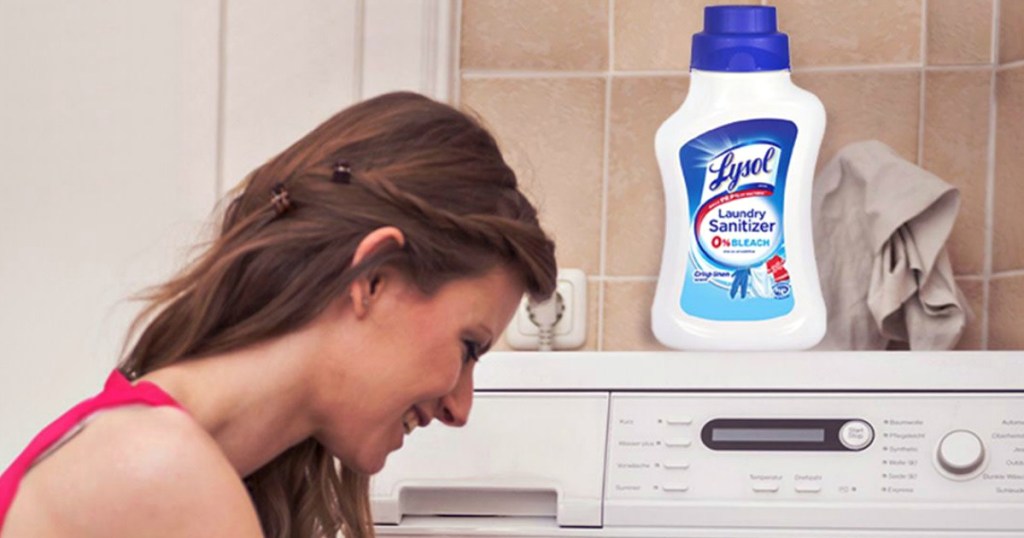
459,0,1024,350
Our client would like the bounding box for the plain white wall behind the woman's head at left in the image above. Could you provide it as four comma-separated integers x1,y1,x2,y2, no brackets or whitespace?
0,0,452,467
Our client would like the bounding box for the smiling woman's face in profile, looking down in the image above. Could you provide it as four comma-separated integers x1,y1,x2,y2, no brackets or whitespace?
318,267,523,473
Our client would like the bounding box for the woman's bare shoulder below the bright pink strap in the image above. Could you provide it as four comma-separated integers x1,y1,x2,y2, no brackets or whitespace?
4,406,261,538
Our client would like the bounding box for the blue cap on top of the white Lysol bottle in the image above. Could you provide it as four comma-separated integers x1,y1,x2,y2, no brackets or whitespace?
690,5,790,73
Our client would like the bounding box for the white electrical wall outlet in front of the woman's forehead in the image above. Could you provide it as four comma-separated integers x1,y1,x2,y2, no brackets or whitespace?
505,268,587,349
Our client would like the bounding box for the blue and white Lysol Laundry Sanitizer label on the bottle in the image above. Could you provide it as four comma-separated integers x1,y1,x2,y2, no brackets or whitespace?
679,119,797,321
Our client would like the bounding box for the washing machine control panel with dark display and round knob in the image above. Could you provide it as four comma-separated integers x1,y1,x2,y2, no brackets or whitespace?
605,392,1024,505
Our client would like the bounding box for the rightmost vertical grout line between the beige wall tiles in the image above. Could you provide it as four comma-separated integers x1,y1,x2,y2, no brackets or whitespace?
981,0,1000,349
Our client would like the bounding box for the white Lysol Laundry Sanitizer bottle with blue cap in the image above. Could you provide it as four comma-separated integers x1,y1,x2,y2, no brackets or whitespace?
651,6,825,350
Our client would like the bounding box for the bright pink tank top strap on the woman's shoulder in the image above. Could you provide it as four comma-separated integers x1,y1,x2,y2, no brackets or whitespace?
0,370,181,533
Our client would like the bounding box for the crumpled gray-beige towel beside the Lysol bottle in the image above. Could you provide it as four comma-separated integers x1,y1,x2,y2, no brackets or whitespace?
813,140,970,349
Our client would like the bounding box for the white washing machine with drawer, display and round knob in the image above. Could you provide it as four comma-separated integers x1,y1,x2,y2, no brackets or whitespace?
371,351,1024,538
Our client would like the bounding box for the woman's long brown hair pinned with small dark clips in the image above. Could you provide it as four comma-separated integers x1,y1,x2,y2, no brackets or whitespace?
120,92,556,538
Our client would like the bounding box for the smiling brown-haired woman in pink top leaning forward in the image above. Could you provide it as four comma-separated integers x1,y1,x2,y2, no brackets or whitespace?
0,93,556,538
